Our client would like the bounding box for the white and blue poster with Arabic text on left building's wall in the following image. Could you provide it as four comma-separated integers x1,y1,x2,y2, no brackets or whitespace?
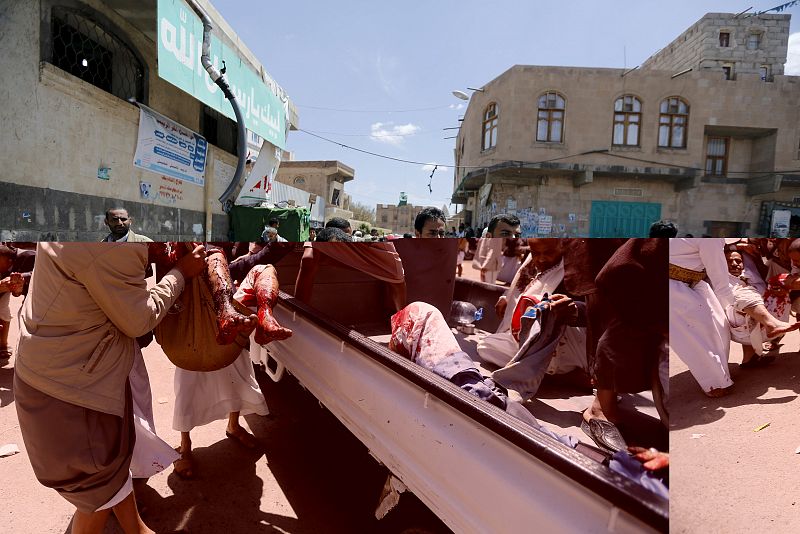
133,104,208,186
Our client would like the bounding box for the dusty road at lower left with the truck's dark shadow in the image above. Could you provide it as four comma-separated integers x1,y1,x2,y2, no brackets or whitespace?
0,299,446,534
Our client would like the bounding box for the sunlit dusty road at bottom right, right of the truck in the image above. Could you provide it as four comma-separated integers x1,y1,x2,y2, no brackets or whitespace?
670,332,800,534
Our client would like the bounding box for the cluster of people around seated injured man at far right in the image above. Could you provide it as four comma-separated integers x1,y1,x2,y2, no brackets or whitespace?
669,238,800,397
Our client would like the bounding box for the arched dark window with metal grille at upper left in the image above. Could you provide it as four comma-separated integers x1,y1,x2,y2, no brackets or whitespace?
44,6,145,102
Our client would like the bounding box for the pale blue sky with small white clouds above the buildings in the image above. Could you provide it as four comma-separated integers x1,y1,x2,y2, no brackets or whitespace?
211,0,800,214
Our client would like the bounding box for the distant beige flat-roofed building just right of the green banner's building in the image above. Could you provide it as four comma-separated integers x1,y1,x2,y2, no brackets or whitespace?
275,161,355,226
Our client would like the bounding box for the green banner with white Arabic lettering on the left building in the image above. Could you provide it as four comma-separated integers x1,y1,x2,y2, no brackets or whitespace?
158,0,288,149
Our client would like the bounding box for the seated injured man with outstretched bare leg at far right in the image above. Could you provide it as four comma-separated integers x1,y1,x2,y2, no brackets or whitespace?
725,250,800,369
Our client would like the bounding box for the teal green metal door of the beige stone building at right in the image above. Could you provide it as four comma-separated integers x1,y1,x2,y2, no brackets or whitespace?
589,200,661,237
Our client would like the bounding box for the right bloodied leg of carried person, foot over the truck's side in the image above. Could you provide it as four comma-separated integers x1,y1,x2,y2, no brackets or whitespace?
237,265,292,345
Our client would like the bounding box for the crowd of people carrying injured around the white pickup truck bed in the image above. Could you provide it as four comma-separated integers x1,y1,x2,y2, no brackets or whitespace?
0,208,672,534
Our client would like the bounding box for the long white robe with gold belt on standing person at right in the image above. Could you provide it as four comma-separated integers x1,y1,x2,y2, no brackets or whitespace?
669,238,734,392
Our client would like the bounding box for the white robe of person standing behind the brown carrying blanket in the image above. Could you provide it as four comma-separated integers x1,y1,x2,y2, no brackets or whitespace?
172,279,269,432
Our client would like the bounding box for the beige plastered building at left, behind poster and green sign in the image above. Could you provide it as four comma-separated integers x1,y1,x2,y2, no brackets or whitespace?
0,0,297,241
